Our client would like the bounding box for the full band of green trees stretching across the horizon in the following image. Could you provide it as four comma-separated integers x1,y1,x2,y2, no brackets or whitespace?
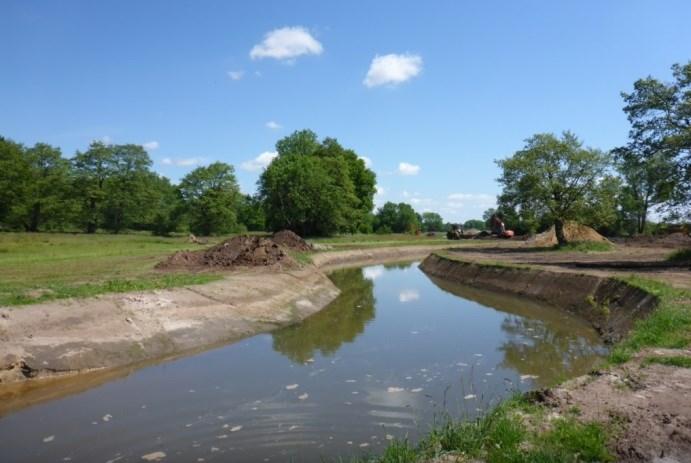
0,63,691,241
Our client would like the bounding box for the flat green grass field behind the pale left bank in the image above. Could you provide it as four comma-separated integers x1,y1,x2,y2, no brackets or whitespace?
0,233,460,306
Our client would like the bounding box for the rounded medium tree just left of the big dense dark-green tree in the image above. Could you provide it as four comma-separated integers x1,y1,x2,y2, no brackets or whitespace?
180,162,240,236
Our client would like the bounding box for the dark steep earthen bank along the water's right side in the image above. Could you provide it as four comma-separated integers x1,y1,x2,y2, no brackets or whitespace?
420,253,659,344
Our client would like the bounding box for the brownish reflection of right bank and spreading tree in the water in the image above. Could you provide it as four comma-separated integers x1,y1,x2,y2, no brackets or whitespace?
430,277,606,387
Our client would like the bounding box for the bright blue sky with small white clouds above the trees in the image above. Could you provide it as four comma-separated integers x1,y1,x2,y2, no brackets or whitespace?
0,0,691,221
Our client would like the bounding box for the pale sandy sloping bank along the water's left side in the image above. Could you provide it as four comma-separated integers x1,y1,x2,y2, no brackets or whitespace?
0,245,440,388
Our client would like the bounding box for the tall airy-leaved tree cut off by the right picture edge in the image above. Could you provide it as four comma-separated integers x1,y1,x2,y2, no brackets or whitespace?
622,62,691,219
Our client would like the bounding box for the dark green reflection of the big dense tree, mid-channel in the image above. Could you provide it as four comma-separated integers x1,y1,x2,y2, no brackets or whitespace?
272,268,376,363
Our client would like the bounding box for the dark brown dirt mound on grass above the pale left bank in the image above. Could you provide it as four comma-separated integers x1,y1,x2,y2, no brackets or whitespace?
156,235,295,269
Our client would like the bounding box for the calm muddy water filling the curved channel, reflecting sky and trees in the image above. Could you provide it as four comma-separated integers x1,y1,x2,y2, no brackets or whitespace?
0,264,606,463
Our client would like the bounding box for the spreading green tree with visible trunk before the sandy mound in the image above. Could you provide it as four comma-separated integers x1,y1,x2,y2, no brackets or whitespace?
497,132,608,244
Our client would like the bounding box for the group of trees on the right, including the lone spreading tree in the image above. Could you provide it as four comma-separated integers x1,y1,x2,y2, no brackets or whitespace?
492,62,691,243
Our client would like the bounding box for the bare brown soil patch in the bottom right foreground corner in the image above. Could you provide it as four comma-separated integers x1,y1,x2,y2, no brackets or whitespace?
544,349,691,462
